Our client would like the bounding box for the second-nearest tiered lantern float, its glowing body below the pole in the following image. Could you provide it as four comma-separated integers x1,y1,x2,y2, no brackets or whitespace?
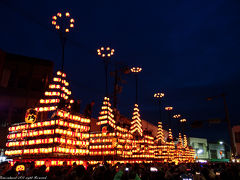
89,97,133,160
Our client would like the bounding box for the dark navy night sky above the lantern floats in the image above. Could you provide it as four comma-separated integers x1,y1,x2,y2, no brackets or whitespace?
0,0,240,141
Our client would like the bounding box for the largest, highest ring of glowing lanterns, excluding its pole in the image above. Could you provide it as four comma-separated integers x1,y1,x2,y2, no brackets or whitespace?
52,12,75,33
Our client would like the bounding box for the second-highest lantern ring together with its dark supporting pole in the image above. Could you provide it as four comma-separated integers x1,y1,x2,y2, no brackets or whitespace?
97,47,115,97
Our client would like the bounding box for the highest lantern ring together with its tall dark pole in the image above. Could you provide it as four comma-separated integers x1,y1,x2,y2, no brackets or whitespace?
52,12,75,72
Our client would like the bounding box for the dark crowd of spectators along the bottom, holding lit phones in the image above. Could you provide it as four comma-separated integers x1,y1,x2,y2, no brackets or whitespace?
0,162,240,180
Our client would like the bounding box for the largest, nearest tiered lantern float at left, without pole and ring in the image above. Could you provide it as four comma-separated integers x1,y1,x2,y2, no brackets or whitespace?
5,71,90,165
